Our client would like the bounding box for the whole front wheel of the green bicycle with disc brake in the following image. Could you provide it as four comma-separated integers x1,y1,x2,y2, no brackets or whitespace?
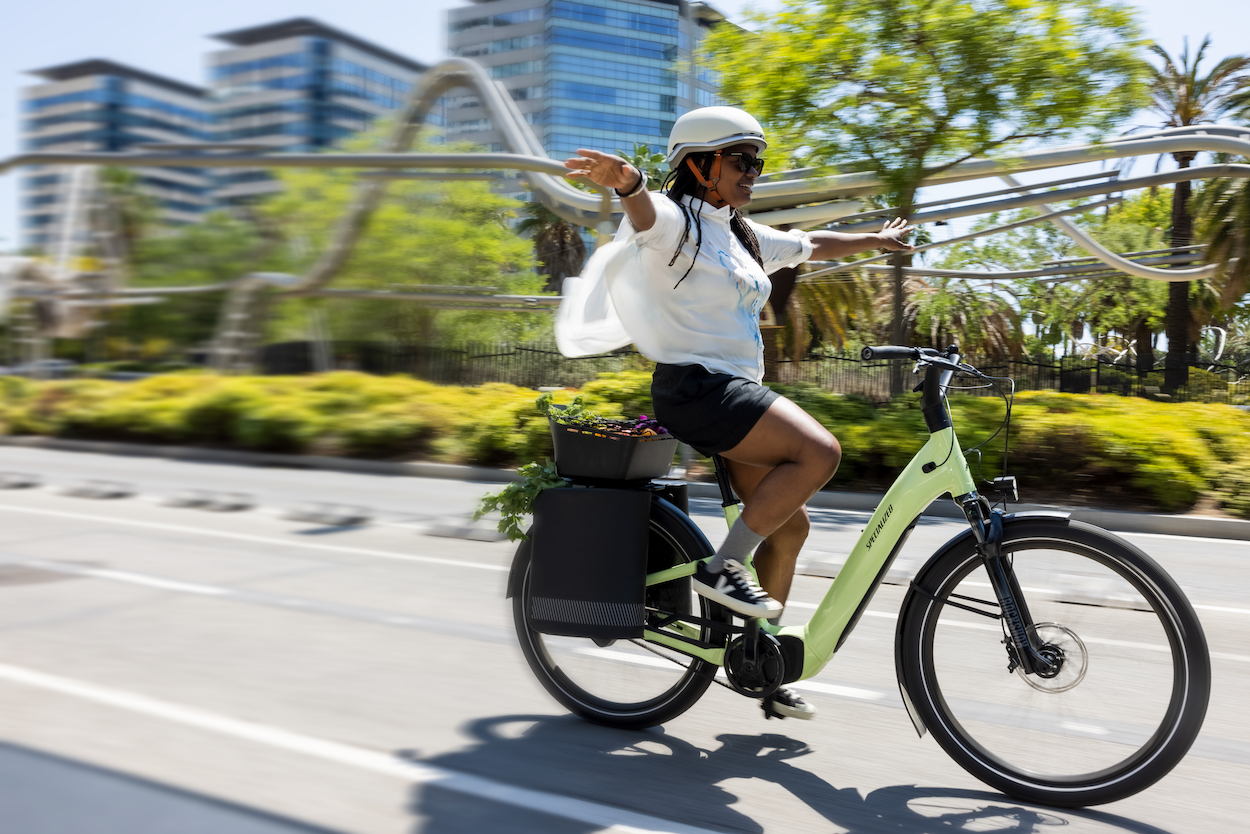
899,518,1211,806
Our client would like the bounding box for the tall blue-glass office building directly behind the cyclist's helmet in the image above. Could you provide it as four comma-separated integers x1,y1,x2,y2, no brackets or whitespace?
446,0,729,159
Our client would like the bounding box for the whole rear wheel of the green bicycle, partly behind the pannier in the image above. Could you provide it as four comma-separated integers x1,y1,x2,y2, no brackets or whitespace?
513,501,730,729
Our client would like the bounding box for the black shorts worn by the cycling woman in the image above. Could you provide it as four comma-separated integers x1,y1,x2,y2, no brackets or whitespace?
651,363,780,455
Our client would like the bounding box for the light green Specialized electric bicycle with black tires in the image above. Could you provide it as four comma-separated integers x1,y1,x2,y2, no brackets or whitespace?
509,346,1211,806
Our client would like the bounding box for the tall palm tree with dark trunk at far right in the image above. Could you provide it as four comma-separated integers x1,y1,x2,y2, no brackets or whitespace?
1150,35,1250,390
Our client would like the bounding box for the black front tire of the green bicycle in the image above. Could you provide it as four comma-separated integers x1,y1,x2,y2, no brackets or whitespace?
899,518,1211,808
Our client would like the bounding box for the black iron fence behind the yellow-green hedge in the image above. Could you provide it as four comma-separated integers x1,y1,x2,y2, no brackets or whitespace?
261,341,1250,405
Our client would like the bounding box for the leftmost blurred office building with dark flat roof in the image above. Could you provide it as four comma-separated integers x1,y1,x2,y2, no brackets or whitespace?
19,59,213,250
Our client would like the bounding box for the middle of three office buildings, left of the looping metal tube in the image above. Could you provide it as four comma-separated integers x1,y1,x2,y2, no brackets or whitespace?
208,18,440,204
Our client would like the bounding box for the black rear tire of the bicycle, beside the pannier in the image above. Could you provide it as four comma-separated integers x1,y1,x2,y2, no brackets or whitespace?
513,501,730,729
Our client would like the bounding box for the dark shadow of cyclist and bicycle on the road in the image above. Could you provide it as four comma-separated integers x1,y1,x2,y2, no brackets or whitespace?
411,715,1171,834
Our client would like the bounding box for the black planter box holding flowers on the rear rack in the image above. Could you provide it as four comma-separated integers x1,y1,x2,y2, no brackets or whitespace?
550,420,678,480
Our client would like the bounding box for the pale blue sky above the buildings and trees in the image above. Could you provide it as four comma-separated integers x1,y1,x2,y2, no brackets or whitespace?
0,0,1250,253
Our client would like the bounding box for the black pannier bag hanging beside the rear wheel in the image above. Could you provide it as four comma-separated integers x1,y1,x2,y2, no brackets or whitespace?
525,486,651,640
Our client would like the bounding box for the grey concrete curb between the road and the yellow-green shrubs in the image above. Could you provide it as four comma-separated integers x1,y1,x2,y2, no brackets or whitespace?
0,436,1250,541
